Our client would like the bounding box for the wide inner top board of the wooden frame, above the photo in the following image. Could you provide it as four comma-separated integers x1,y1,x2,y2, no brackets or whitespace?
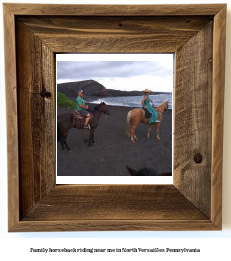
19,16,212,53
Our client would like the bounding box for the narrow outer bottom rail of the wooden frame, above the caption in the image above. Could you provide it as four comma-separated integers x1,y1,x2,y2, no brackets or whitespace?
10,220,219,232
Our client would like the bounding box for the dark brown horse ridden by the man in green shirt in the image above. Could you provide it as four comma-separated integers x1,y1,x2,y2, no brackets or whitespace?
57,102,110,150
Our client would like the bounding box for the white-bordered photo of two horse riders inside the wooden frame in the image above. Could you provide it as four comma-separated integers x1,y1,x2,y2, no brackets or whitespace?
56,54,174,184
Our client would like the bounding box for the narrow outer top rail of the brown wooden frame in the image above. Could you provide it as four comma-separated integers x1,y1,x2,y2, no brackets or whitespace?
4,3,224,16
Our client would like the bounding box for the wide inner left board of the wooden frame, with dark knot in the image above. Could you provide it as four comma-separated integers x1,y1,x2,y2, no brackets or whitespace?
16,20,56,218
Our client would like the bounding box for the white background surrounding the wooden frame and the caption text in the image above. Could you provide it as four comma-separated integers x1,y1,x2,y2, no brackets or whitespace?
0,0,231,260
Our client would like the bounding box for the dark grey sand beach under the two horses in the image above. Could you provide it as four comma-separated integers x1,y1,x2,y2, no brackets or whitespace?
57,103,172,176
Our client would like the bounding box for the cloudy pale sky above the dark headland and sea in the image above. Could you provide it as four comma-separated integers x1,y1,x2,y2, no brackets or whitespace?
57,56,173,91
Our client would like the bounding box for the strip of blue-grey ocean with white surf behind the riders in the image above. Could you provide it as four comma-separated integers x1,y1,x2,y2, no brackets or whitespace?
92,93,172,109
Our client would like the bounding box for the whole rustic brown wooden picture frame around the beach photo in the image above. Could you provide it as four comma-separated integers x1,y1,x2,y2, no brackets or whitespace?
3,4,226,232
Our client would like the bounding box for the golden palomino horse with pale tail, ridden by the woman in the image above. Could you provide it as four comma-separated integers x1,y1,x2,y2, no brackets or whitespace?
126,101,168,143
